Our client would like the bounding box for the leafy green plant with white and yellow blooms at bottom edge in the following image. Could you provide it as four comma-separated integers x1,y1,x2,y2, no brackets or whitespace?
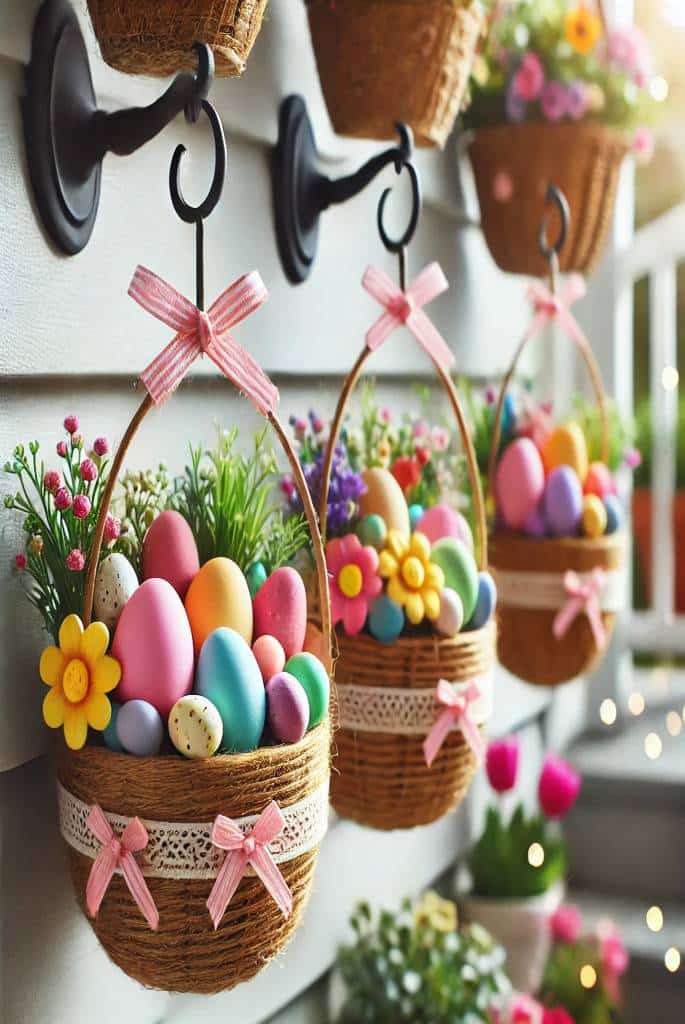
338,893,511,1024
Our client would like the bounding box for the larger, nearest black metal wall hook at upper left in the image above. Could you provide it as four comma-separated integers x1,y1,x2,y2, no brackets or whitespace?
22,0,214,255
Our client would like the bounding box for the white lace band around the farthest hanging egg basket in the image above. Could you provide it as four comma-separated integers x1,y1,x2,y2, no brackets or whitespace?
490,567,628,611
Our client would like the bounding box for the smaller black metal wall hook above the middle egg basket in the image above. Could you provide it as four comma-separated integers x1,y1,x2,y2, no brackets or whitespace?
271,95,416,285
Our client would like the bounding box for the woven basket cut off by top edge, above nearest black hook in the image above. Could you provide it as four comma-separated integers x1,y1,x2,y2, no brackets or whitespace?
88,0,268,78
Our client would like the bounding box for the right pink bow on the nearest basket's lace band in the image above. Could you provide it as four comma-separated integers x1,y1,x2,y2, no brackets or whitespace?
202,800,293,929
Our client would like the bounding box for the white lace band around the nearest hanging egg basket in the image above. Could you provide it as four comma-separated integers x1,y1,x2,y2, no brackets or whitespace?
57,779,329,879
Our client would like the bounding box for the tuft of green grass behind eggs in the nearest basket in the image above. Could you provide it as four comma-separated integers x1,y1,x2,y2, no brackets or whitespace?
169,427,308,572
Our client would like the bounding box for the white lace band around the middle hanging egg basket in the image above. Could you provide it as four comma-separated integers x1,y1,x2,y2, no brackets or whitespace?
336,674,493,736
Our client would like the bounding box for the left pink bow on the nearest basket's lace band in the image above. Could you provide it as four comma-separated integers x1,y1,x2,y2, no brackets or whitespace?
86,804,160,932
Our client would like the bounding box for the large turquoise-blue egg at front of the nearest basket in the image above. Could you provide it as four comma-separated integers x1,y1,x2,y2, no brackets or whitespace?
195,626,266,753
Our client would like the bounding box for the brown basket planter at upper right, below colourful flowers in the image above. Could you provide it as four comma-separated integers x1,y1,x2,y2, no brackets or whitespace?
470,121,628,276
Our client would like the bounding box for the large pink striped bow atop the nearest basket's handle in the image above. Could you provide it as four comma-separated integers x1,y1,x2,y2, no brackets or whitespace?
128,266,279,416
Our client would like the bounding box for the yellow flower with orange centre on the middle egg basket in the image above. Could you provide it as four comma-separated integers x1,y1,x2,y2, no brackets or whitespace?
379,529,444,626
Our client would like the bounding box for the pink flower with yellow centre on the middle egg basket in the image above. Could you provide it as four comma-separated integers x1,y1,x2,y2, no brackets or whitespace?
326,534,383,636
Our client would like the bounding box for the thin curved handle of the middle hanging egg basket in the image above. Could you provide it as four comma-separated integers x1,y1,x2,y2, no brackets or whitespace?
318,345,487,569
